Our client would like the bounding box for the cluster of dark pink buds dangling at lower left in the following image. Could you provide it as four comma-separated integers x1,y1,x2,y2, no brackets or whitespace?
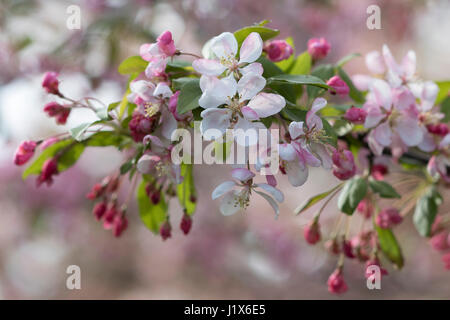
86,175,128,237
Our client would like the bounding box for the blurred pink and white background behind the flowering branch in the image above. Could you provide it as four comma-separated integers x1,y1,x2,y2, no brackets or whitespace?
0,0,450,299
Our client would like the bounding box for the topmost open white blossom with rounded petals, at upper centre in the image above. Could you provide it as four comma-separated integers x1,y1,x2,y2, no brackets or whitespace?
192,32,263,76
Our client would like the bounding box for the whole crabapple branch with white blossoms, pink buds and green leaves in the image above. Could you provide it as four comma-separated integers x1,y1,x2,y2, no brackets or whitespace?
14,22,450,293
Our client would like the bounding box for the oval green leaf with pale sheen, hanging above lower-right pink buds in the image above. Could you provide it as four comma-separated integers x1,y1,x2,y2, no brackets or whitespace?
338,177,367,215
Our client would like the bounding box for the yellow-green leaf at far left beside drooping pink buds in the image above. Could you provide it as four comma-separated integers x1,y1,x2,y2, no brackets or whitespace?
22,139,84,179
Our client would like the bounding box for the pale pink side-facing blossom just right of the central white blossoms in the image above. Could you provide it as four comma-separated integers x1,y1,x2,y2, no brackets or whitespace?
279,98,332,187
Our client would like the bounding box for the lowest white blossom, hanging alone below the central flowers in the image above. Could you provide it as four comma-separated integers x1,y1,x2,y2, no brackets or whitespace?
211,168,284,216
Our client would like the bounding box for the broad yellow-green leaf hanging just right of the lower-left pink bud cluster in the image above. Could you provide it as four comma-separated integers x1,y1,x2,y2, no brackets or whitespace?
136,180,167,234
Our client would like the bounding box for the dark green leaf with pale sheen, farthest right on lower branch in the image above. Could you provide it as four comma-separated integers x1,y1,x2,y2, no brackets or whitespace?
413,186,442,237
